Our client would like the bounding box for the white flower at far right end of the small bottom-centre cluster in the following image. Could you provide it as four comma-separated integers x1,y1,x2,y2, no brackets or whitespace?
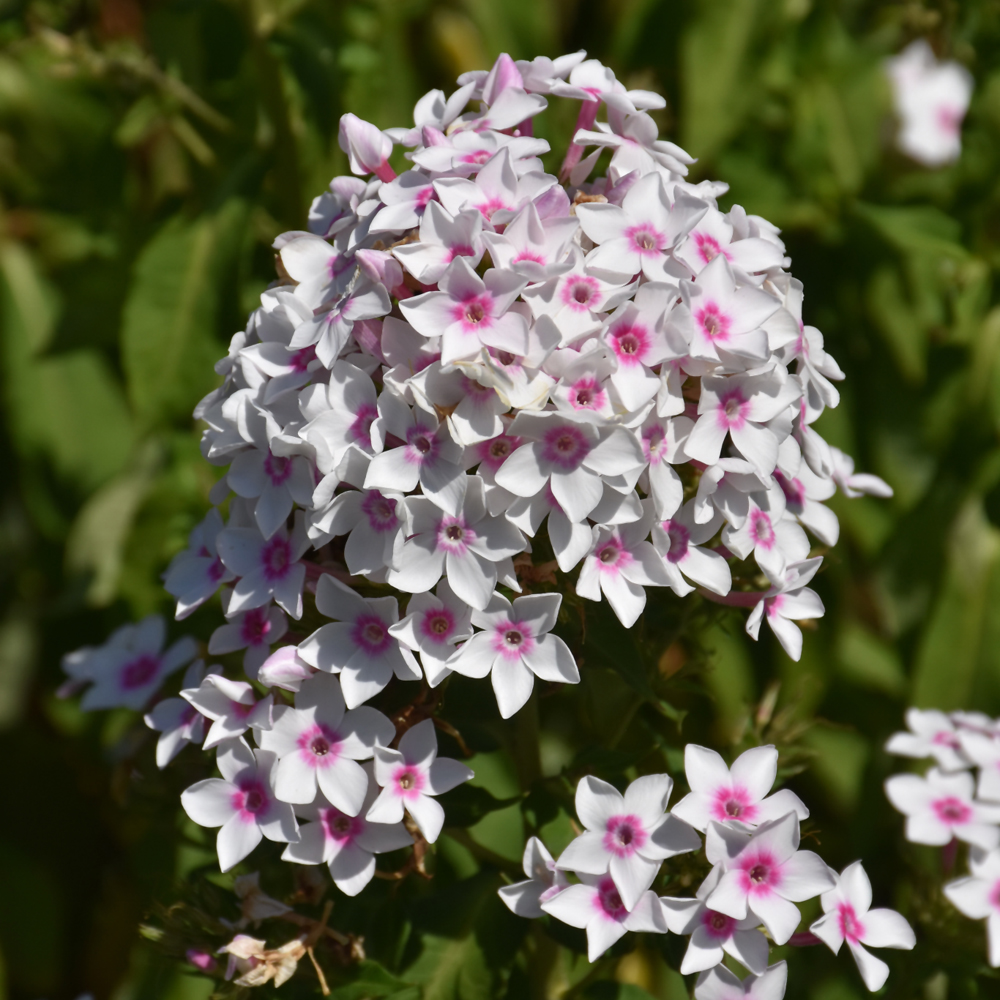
809,861,917,993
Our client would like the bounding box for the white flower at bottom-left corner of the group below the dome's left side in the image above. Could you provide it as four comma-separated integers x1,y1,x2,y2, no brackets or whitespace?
181,738,299,871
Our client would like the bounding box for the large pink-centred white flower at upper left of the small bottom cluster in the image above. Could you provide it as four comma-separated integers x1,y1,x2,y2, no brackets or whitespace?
557,774,701,919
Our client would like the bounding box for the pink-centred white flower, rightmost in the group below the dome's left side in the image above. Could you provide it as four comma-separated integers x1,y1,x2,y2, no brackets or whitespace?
365,719,474,844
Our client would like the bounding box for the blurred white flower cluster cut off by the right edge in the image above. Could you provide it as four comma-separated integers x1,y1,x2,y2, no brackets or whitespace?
885,708,1000,968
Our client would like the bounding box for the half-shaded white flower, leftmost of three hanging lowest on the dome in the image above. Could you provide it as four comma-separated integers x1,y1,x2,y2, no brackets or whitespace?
298,573,421,709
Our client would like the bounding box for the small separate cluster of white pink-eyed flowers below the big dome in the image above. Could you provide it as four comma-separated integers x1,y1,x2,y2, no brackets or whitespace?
500,744,916,1000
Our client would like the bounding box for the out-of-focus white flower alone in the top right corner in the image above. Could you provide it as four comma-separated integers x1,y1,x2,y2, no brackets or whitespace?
886,38,972,167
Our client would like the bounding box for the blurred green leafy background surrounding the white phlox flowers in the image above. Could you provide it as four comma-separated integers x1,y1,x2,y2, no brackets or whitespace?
0,0,1000,1000
